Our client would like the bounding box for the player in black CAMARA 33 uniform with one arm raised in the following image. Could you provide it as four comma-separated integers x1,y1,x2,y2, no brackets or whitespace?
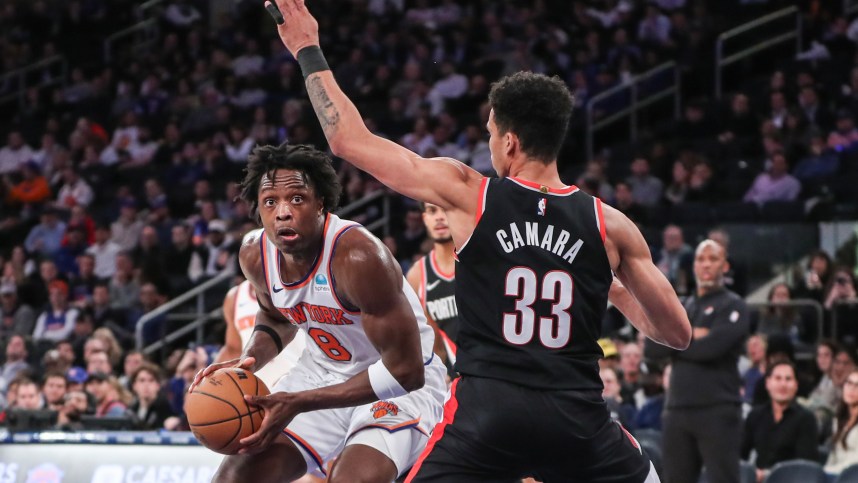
266,0,691,483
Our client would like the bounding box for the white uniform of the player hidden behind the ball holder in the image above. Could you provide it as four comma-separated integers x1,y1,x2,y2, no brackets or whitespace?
232,280,307,389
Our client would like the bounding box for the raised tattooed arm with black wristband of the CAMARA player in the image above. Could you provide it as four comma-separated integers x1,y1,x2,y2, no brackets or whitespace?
266,0,482,242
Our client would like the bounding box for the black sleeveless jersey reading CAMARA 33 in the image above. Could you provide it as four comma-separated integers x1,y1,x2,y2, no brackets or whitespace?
456,178,613,390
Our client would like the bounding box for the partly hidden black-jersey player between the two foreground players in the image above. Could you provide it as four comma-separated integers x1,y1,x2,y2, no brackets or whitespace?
405,203,459,377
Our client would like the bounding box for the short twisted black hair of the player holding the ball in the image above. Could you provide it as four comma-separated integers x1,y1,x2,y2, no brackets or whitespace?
241,143,342,221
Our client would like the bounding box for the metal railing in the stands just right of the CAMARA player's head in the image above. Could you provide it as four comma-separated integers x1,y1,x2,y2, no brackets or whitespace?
586,62,681,159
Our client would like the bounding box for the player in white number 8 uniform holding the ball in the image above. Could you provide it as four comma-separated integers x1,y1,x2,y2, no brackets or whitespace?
186,145,446,483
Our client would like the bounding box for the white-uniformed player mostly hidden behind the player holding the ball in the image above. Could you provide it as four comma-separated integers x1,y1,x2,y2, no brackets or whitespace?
215,280,306,388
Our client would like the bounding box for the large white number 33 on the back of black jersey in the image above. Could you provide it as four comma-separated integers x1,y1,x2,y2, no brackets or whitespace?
503,267,574,349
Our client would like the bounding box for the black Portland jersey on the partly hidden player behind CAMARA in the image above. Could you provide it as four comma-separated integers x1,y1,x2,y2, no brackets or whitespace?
418,250,459,342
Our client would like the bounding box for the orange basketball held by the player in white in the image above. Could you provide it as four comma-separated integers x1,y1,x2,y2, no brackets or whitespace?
185,367,270,455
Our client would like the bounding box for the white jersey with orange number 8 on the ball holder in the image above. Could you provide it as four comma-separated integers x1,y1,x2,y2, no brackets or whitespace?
259,214,435,378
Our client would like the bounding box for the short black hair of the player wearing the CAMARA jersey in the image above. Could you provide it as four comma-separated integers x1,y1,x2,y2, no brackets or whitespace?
489,72,575,163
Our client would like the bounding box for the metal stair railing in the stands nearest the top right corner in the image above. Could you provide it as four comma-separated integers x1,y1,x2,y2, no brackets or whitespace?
715,6,800,99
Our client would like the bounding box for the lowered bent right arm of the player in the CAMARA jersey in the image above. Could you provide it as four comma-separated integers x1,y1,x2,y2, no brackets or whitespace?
603,205,691,349
